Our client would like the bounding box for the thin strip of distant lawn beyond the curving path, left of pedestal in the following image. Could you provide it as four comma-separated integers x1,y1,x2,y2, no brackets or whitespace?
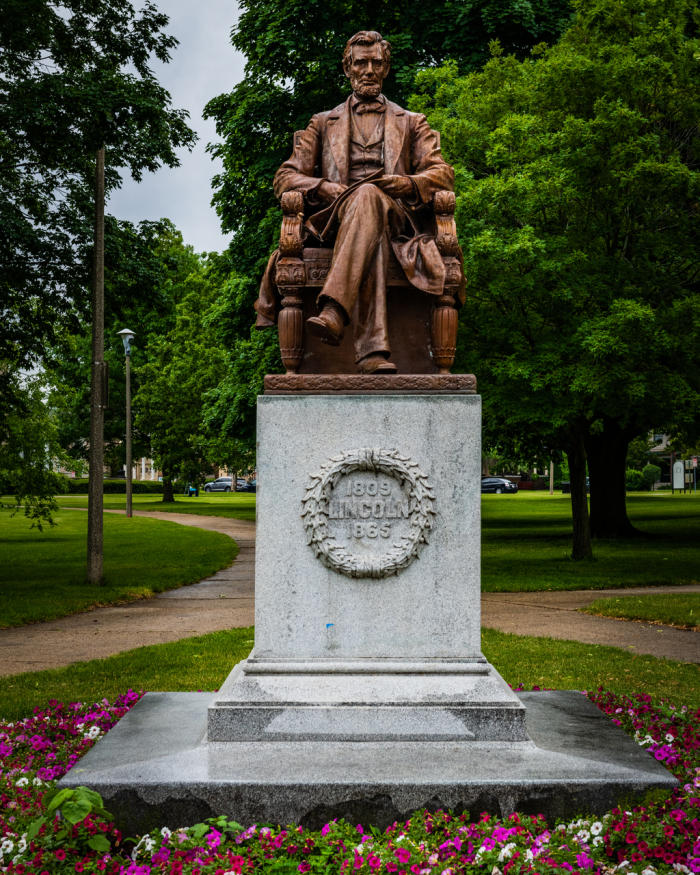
56,491,255,522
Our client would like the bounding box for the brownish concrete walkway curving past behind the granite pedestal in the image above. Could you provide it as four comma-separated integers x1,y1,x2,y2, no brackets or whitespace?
0,511,700,675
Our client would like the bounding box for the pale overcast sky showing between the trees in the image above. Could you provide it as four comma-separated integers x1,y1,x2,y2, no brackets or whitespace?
107,0,243,252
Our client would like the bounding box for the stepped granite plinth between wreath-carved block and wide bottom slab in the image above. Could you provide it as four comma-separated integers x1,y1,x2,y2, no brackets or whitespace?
207,655,528,742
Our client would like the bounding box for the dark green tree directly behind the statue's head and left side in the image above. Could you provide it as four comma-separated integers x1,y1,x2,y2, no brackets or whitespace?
206,0,571,452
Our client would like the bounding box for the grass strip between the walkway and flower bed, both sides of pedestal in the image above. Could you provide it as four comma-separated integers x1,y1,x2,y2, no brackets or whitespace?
0,628,700,720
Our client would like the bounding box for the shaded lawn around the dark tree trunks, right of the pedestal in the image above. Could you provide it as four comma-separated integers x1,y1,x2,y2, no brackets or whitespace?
482,492,700,592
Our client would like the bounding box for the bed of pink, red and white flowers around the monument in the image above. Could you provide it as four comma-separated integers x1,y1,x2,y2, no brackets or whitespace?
0,690,700,875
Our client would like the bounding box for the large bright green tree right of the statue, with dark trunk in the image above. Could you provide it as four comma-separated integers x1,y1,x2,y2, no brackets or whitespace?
410,0,700,555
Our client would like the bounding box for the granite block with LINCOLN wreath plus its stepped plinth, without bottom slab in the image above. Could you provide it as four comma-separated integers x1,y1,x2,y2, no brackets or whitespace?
208,392,527,742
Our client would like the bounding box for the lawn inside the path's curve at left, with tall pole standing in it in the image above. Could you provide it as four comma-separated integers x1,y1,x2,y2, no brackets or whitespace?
0,509,238,627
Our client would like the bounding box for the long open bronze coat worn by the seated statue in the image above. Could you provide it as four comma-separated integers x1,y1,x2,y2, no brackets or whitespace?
255,98,463,320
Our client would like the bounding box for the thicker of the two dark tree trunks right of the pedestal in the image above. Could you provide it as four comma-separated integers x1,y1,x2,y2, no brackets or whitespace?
586,420,639,538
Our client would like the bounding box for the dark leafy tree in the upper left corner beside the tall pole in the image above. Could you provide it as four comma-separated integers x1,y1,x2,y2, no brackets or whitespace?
0,0,195,528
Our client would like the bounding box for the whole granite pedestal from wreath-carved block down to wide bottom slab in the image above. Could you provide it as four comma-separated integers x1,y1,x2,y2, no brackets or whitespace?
61,386,675,833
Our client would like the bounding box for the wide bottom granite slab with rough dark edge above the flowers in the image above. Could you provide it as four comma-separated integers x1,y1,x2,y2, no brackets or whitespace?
60,691,677,835
